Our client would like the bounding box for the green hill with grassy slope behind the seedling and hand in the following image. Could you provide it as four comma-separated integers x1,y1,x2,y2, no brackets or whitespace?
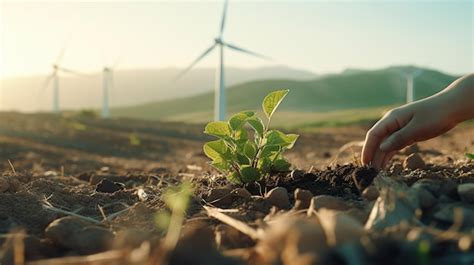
113,66,456,123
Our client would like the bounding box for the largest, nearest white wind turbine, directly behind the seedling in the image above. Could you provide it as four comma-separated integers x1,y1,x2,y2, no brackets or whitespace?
177,0,270,121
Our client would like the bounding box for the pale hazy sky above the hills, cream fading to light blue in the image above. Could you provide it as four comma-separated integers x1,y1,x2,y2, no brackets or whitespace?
0,0,474,77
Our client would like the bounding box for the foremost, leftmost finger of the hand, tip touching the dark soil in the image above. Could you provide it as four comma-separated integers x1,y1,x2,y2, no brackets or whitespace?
361,112,404,164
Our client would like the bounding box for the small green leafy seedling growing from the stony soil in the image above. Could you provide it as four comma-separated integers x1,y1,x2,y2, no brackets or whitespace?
203,90,298,184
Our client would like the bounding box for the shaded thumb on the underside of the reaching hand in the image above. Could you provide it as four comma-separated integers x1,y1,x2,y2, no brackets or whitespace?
380,122,417,153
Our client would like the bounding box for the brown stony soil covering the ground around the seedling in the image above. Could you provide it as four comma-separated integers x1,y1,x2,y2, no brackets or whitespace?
0,113,474,265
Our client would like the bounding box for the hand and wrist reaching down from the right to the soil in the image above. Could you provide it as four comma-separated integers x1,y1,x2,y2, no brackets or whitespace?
362,75,474,169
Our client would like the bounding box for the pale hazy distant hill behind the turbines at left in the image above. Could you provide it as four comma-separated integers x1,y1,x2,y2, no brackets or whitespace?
0,66,316,111
